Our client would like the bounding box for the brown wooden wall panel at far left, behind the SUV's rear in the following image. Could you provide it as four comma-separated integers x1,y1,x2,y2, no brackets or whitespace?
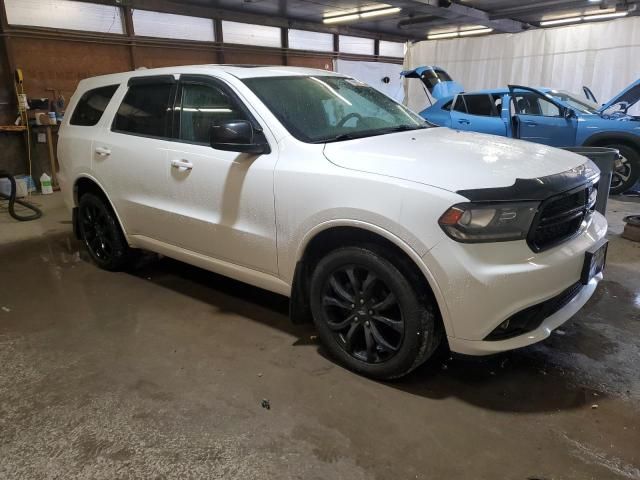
13,37,131,100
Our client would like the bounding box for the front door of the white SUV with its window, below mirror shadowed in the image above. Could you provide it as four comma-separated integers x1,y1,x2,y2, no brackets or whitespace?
165,75,278,273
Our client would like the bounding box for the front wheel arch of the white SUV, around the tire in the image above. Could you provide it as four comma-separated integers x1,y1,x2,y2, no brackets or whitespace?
289,221,452,340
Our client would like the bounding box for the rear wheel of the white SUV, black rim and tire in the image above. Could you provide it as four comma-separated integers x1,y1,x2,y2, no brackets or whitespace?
78,193,131,271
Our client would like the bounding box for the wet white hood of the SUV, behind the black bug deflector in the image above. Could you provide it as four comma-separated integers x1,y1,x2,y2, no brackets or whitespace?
324,127,587,192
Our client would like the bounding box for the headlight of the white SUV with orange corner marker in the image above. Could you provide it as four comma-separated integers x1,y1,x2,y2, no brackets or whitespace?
438,202,540,243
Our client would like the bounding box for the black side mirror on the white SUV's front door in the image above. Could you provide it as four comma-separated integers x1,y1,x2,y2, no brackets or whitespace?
209,120,271,155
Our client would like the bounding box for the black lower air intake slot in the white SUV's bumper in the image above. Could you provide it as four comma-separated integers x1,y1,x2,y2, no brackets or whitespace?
485,282,583,341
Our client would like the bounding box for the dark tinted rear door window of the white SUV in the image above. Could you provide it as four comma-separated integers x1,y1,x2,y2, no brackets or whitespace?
113,83,174,137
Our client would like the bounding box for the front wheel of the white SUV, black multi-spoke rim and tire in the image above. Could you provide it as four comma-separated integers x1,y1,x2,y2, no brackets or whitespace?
310,247,441,380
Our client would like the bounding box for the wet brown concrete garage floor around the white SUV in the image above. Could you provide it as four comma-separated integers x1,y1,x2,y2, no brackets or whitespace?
0,195,640,480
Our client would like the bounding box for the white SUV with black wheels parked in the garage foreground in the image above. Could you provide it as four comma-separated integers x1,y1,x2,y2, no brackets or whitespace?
58,65,607,378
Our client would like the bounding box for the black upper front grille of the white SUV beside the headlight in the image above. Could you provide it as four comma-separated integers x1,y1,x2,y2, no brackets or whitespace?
528,184,597,252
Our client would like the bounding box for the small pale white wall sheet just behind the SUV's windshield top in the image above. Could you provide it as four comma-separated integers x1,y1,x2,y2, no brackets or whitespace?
334,60,404,102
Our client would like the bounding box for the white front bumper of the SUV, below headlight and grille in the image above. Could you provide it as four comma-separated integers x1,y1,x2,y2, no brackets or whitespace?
423,212,607,355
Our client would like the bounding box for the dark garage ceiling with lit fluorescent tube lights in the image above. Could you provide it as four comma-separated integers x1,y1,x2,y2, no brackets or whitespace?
172,0,640,40
